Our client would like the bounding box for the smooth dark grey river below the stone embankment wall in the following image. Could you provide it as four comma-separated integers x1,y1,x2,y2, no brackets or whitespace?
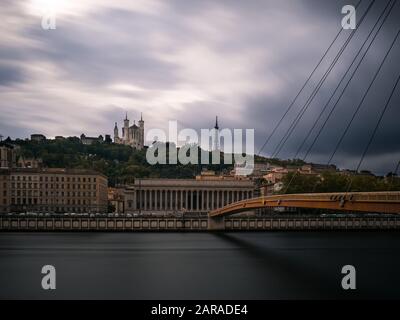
0,231,400,299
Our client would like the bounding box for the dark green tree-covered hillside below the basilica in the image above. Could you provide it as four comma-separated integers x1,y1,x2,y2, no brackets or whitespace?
12,137,233,186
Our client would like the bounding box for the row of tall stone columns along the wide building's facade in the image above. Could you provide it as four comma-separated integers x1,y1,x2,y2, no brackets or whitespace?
133,189,253,212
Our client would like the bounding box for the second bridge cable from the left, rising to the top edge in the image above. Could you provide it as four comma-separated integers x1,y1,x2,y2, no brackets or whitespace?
271,0,375,158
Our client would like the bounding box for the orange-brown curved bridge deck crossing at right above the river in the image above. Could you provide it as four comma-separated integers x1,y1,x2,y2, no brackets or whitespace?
209,191,400,218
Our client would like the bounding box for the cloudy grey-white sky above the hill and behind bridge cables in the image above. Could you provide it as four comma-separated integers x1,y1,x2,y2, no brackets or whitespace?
0,0,400,173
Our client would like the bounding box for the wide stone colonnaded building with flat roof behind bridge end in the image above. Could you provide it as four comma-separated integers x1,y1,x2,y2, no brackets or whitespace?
119,171,255,213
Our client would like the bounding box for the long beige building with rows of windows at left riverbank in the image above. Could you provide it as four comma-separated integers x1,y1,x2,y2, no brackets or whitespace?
0,168,108,213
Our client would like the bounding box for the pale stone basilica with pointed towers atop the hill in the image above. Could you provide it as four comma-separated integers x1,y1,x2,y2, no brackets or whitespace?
114,113,144,150
